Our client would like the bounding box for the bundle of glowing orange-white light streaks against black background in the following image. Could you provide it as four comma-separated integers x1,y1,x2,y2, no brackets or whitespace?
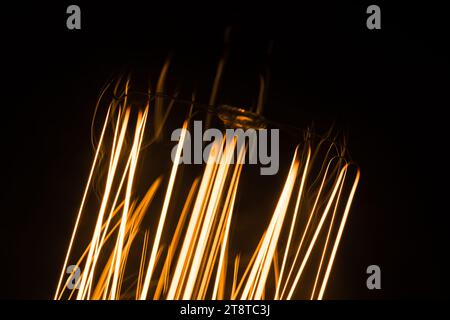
54,57,359,299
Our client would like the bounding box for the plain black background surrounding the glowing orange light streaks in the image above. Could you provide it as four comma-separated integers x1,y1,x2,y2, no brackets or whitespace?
0,1,450,299
